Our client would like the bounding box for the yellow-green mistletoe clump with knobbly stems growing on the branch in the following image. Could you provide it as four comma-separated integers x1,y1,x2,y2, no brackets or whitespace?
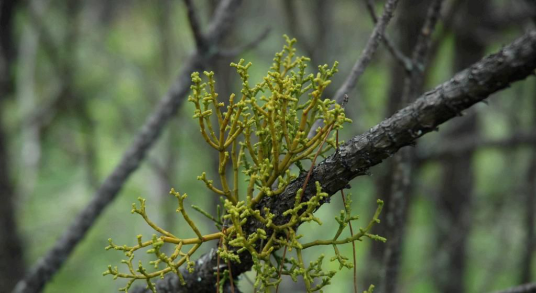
104,36,385,292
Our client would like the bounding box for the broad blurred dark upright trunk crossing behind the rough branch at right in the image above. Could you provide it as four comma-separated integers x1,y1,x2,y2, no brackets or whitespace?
432,0,489,293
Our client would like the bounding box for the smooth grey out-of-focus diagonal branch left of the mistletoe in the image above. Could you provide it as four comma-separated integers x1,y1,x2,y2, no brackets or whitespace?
14,0,241,293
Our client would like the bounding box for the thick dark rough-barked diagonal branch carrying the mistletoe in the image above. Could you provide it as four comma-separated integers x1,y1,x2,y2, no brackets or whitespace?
133,31,536,292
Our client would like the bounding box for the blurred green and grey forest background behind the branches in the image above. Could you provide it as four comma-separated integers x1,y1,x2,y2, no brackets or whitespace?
0,0,536,293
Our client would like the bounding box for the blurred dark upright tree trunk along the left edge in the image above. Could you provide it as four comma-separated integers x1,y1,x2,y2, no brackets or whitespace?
0,0,24,292
